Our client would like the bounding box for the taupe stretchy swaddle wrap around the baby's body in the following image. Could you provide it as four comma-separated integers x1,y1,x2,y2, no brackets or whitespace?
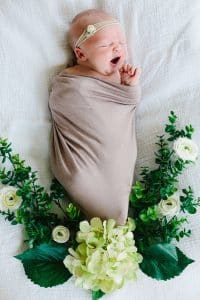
49,71,140,224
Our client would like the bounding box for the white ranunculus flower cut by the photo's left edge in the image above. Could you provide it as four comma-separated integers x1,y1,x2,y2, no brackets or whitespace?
0,186,22,211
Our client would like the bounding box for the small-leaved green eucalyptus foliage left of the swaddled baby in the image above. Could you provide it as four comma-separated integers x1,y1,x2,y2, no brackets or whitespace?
0,138,81,248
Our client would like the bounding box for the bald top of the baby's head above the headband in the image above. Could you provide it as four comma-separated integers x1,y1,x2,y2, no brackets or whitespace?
68,9,116,50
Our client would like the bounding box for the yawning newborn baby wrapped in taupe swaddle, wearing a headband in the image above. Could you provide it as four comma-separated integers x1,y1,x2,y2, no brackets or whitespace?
49,9,140,224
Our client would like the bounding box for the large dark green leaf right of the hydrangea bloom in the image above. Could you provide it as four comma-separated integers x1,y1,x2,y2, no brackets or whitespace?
140,244,194,280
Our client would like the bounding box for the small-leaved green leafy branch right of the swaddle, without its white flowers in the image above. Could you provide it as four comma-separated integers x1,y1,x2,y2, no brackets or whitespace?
130,112,200,251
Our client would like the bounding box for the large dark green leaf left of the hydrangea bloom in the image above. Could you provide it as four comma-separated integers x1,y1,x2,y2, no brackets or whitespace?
15,243,72,287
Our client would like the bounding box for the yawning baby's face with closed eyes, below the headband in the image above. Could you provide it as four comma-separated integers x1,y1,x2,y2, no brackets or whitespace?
76,24,127,75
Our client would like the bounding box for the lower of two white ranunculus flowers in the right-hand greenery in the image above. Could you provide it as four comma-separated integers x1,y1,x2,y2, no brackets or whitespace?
158,192,180,220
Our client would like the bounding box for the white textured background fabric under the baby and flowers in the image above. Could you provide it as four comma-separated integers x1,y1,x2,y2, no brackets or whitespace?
0,0,200,300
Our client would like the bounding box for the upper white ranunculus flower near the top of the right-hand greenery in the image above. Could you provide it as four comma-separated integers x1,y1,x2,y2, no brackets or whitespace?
173,137,198,161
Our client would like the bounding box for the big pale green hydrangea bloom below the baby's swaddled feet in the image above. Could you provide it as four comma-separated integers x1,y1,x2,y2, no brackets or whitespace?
64,218,142,293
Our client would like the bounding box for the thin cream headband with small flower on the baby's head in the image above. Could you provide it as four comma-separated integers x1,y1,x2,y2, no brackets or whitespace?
75,19,119,48
